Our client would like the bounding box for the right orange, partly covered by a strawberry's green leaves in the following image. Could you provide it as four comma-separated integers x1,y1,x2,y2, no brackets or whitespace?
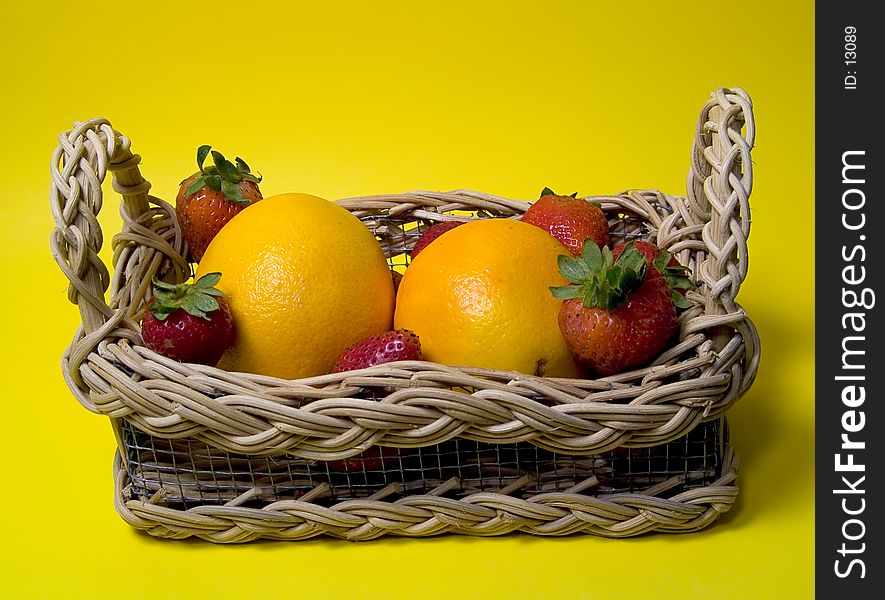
394,219,578,377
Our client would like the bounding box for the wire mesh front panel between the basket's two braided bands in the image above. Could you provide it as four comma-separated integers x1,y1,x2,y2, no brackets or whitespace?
121,420,726,509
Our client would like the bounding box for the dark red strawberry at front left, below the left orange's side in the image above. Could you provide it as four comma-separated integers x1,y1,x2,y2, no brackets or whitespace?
141,273,235,366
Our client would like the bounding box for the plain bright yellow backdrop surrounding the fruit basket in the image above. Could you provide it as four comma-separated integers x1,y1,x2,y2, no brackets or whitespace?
0,0,814,598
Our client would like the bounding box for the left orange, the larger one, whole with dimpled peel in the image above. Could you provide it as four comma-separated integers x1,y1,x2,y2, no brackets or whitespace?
198,194,394,379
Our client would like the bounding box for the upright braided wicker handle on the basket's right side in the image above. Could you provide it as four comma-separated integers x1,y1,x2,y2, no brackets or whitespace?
687,88,756,322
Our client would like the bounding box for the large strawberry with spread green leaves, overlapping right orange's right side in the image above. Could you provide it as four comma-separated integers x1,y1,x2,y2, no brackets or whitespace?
550,243,678,377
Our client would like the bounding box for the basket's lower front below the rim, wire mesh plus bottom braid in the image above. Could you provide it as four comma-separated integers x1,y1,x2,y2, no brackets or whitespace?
116,418,737,542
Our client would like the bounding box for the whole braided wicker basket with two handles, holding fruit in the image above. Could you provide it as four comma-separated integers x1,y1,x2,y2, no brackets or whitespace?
51,89,759,542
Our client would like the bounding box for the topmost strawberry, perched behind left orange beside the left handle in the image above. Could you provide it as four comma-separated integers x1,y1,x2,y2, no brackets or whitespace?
175,145,262,262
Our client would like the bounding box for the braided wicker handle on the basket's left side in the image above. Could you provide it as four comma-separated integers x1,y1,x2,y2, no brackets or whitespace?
49,118,189,402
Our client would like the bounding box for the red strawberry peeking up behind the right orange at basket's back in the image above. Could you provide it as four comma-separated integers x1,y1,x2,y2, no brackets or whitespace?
520,188,610,256
